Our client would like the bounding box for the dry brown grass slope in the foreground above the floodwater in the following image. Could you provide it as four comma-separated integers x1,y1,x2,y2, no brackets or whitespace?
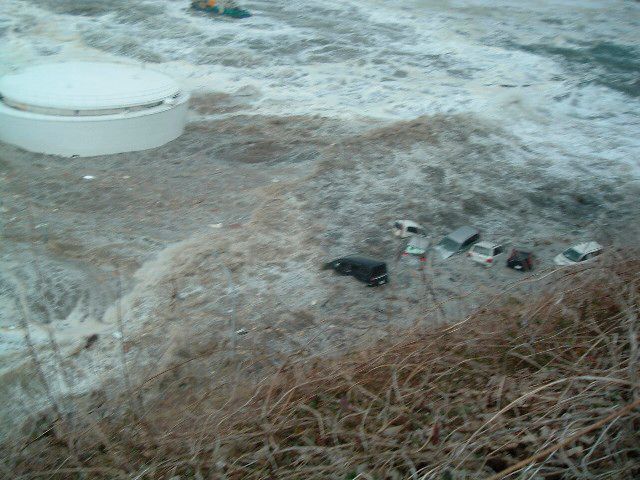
3,258,640,480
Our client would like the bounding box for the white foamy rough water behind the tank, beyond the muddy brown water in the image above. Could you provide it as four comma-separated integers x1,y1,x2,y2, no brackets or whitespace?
0,0,640,174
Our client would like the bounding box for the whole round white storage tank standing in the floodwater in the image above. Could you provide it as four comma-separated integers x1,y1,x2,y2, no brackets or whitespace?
0,62,189,157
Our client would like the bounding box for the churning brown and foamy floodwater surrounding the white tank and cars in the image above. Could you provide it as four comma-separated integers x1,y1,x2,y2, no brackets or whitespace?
0,0,640,434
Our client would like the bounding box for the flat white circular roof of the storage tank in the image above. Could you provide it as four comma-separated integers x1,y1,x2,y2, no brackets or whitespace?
0,62,180,110
